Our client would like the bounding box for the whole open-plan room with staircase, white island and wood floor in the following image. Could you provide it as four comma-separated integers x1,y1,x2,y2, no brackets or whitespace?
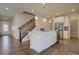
0,3,79,55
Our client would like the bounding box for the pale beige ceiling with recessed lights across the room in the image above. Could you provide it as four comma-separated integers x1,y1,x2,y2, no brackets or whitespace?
0,3,79,17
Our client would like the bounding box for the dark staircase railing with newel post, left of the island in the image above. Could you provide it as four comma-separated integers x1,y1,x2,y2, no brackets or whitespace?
18,17,36,42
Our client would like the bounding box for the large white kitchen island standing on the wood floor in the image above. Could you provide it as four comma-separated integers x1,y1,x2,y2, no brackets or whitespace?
30,31,57,53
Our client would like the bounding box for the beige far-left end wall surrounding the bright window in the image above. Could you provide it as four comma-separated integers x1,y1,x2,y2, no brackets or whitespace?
0,20,11,36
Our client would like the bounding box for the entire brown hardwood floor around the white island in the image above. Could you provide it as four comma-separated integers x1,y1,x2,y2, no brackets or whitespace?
0,36,79,55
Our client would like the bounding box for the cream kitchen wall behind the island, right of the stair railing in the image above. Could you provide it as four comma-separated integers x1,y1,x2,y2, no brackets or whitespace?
34,16,49,31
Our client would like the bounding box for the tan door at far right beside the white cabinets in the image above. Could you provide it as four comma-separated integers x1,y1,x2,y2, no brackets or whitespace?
70,19,78,39
